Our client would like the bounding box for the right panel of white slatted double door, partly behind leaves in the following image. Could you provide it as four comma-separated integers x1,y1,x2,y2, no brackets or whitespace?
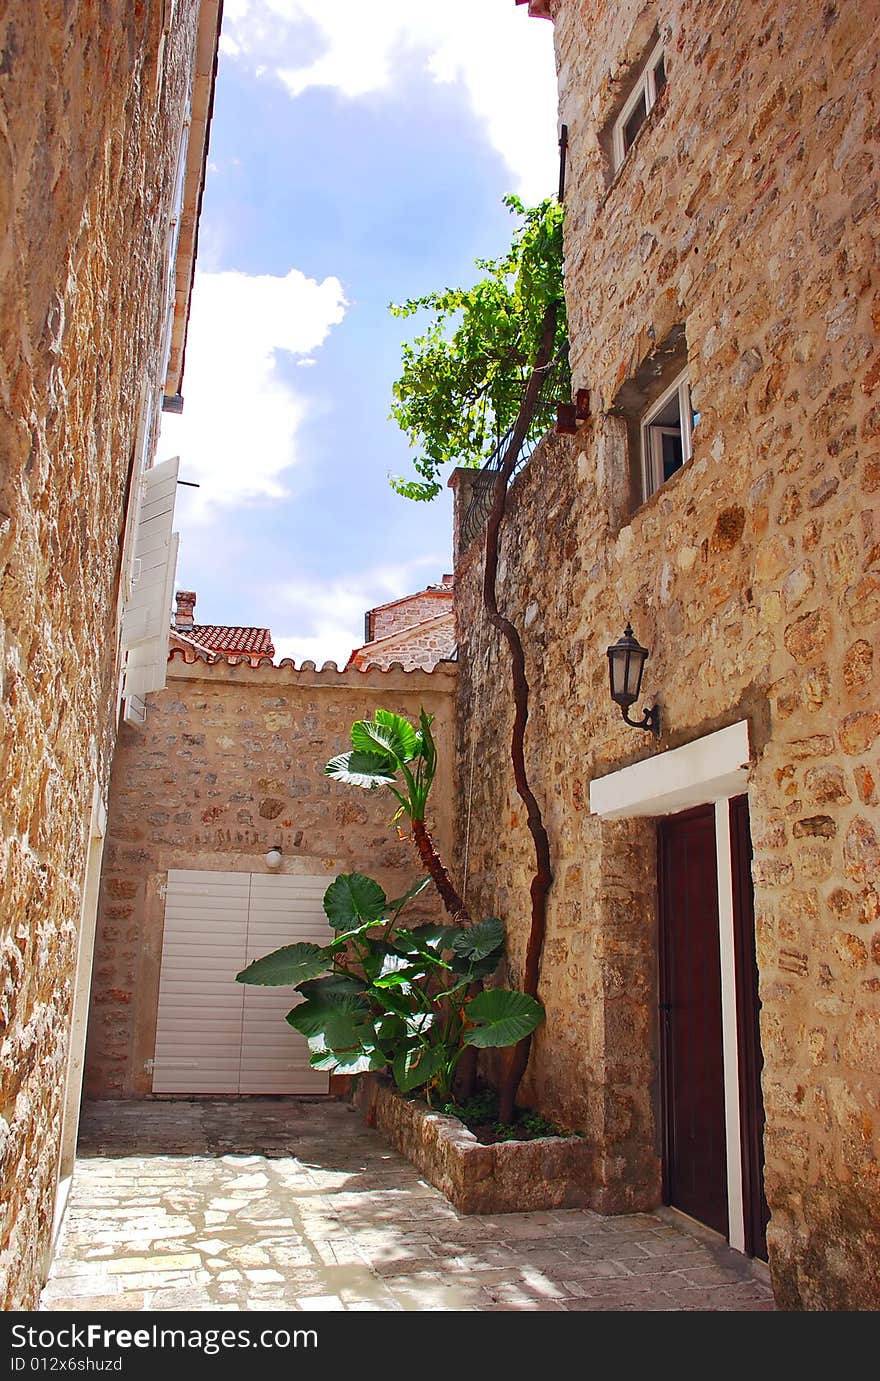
239,873,333,1094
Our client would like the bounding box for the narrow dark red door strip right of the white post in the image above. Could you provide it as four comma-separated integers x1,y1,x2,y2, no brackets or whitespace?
731,795,769,1261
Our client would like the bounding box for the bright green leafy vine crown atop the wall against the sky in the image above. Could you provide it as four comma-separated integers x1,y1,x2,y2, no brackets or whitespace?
390,196,568,500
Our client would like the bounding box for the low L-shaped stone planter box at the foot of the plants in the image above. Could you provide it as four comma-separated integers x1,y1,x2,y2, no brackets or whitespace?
352,1074,593,1214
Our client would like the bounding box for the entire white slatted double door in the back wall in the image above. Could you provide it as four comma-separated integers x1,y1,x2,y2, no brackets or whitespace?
153,869,333,1094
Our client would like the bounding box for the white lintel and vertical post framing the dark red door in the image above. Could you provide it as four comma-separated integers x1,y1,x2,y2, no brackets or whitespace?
590,720,752,1251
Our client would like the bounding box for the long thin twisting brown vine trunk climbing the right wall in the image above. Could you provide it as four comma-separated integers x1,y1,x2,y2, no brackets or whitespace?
484,302,557,1123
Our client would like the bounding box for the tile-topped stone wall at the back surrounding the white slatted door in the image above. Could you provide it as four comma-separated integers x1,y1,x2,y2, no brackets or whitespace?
86,655,456,1098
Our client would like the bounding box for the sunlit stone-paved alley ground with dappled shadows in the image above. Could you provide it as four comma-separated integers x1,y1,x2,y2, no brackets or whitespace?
40,1098,774,1312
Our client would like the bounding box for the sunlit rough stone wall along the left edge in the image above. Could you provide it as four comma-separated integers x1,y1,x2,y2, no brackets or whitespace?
0,0,196,1309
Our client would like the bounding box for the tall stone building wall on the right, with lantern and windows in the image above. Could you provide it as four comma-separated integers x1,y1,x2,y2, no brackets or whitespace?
456,0,880,1309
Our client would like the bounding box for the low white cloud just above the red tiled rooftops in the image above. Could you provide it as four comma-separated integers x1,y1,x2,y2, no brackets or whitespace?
272,555,445,668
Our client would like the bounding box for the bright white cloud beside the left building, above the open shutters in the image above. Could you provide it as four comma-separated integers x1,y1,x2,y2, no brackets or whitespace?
159,268,347,518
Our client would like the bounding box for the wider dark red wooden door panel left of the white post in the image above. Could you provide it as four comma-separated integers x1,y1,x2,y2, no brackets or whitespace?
658,805,728,1236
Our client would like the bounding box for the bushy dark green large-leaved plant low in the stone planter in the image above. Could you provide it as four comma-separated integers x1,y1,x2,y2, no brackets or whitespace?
236,872,543,1101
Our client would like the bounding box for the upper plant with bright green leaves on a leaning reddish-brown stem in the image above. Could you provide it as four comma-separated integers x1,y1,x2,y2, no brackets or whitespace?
323,710,471,924
